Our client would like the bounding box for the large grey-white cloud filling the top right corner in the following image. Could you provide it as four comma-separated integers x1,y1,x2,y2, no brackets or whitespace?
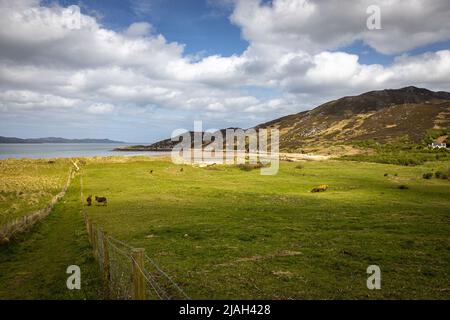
231,0,450,54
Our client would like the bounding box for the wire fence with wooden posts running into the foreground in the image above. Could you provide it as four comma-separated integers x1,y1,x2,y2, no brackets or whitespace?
80,174,190,300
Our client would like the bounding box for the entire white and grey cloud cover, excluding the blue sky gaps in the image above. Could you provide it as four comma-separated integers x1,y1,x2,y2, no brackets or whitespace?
0,0,450,141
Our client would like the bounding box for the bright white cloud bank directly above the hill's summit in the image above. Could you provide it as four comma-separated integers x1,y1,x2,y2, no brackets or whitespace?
279,50,450,97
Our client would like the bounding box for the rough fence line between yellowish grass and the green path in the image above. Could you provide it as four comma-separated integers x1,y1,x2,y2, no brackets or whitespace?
0,167,78,246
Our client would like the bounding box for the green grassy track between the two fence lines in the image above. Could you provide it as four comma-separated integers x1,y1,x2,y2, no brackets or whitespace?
0,176,101,299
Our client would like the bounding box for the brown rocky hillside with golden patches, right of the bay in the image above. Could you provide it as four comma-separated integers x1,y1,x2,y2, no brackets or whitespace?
256,87,450,150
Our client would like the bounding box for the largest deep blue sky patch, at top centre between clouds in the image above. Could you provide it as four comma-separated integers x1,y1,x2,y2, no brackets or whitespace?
44,0,248,56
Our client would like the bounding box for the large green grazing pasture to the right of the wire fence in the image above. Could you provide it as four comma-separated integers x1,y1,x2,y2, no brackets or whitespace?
79,159,450,299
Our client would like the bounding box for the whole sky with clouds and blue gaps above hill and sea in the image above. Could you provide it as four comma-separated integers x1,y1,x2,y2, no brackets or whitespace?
0,0,450,142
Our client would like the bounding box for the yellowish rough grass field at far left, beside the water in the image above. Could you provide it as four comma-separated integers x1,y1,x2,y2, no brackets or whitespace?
0,159,71,226
